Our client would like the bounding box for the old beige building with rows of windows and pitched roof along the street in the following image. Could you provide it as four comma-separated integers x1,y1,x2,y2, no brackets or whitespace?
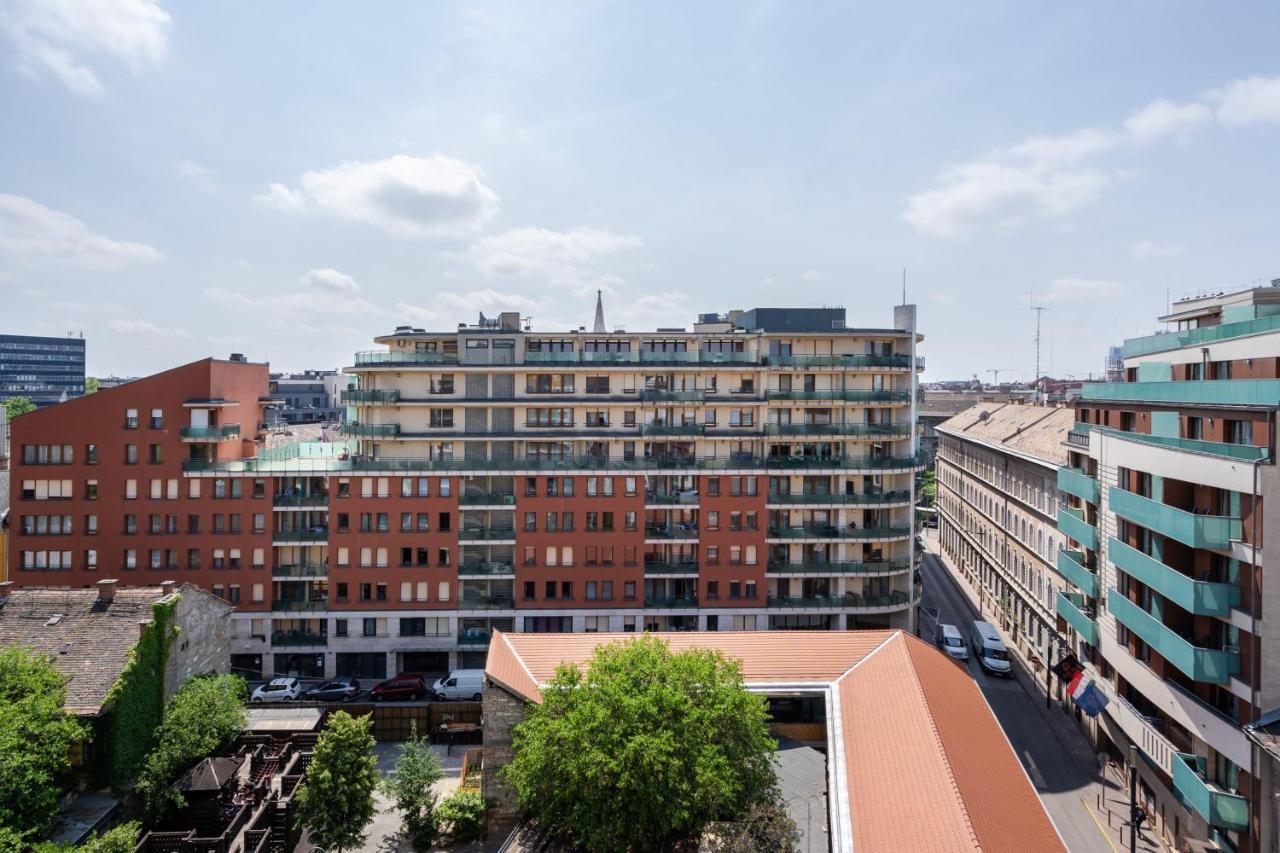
937,402,1075,661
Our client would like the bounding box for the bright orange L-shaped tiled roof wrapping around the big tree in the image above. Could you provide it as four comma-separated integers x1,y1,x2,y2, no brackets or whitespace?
485,630,1065,853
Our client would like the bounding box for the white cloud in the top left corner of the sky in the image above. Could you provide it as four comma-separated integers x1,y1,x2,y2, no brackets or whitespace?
0,0,170,95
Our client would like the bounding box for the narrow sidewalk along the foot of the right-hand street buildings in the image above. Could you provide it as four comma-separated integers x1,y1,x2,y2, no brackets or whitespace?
923,533,1171,853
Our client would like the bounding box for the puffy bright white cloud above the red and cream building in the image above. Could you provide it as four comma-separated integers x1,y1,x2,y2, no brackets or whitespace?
255,154,499,240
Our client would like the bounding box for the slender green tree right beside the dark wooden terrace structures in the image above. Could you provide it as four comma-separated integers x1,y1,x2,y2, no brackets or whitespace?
296,711,378,850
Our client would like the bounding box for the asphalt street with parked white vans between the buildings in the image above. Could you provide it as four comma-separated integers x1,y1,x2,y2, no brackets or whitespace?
920,537,1165,853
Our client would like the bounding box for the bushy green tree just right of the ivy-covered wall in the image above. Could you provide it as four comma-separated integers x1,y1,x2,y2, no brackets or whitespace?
137,675,248,820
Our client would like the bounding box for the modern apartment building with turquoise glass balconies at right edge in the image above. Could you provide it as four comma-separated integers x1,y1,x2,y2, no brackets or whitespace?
1057,286,1280,850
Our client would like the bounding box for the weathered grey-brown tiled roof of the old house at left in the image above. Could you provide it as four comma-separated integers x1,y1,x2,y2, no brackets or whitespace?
0,587,172,716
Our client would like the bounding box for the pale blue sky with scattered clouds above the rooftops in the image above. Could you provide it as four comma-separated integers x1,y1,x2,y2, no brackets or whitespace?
0,0,1280,379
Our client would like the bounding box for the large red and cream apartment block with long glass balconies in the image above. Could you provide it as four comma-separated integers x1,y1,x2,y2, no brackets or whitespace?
10,300,922,678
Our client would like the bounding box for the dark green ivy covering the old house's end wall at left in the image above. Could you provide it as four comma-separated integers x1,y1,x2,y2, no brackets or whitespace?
93,596,180,790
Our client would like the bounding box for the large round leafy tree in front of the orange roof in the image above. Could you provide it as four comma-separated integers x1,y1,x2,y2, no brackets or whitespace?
502,637,776,853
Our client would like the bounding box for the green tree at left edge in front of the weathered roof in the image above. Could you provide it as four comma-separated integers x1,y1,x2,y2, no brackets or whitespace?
0,647,90,838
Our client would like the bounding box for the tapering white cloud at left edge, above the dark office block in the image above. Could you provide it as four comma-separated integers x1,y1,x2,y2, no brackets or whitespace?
0,193,161,268
